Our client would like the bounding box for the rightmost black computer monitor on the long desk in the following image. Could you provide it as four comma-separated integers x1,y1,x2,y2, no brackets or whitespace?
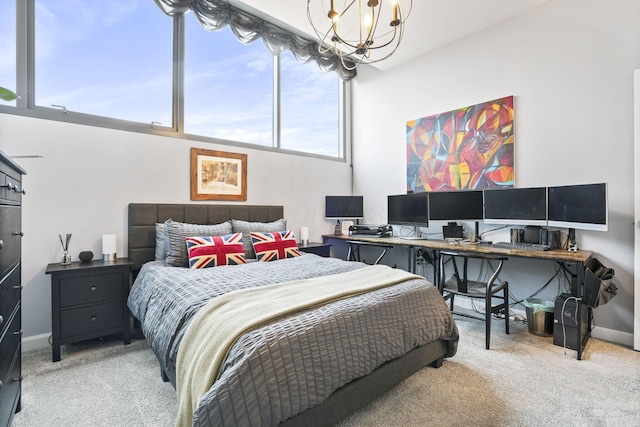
548,183,609,231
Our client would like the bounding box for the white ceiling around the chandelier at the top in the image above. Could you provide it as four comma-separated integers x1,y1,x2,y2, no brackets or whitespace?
232,0,550,70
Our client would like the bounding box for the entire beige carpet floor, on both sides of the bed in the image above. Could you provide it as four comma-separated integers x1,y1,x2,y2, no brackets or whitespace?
13,318,640,427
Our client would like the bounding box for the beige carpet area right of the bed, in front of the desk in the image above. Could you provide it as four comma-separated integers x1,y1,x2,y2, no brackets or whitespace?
343,317,640,427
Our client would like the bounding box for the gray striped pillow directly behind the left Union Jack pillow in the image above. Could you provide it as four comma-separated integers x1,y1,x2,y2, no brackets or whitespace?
164,220,232,267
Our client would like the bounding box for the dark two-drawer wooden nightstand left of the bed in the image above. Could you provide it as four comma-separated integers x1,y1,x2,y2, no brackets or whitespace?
45,258,133,362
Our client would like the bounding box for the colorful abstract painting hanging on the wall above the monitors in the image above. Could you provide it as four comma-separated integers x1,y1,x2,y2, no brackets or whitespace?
407,96,514,192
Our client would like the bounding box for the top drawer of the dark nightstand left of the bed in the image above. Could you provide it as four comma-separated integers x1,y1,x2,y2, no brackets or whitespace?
60,272,123,307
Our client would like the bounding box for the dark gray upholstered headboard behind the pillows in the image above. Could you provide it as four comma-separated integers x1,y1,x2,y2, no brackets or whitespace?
127,203,284,270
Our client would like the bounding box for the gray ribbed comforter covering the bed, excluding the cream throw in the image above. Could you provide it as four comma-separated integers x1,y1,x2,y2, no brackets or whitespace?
129,254,458,426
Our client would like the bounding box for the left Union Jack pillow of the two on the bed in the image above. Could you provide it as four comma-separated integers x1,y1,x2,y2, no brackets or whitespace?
185,233,247,268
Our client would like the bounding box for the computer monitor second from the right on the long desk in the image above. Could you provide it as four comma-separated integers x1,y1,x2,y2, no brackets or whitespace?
484,187,547,226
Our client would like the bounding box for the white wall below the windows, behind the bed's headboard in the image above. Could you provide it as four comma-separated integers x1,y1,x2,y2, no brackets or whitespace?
0,114,351,341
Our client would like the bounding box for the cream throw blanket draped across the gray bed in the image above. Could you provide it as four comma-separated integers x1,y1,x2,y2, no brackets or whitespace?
176,265,424,426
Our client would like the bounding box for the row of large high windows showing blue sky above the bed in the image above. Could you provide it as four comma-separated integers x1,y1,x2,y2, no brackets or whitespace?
0,0,353,159
